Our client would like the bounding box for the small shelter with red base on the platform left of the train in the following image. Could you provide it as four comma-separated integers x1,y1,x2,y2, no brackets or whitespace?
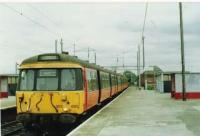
0,74,18,98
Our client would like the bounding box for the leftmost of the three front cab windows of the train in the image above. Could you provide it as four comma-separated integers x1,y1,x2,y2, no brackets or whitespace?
20,70,34,90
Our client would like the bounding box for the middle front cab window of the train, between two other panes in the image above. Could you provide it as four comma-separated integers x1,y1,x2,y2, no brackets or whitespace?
36,69,58,90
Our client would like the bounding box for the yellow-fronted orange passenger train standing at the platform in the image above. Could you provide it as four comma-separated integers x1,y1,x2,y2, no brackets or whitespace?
16,53,128,127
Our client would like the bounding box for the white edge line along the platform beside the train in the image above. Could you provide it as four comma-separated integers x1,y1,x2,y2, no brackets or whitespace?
66,88,128,136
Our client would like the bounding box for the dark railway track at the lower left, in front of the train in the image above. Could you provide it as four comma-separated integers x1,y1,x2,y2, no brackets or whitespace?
1,120,24,136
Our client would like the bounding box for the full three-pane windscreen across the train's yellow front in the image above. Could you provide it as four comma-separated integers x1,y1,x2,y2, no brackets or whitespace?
19,68,83,91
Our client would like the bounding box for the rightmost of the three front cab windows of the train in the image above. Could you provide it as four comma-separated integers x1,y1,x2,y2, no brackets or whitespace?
61,69,83,90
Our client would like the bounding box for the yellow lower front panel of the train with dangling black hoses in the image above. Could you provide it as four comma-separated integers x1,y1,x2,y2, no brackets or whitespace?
16,90,84,114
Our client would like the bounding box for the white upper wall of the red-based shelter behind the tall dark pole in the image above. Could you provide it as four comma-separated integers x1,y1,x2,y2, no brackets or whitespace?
175,74,200,92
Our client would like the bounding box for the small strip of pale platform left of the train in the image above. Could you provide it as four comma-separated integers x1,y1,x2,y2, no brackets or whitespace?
0,96,16,110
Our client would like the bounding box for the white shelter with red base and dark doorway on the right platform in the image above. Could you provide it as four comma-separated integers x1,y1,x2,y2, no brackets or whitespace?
156,71,200,99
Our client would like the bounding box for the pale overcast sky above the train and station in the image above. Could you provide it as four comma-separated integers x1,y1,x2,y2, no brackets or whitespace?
0,2,200,74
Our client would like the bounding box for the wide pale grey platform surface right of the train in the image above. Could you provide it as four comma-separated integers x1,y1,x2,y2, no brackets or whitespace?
68,87,200,136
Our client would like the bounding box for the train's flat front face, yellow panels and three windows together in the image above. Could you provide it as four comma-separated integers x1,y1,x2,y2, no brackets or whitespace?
16,62,85,114
